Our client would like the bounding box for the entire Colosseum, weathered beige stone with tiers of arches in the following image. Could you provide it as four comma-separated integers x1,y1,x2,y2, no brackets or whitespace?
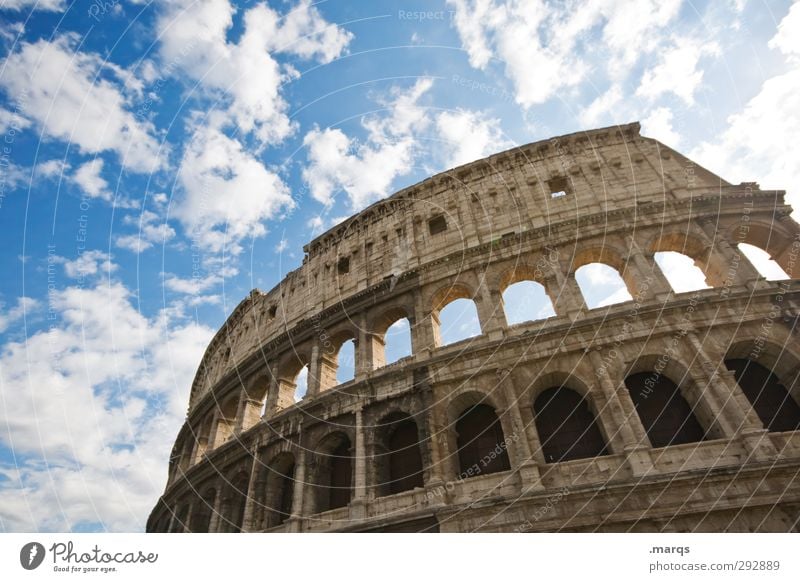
147,123,800,532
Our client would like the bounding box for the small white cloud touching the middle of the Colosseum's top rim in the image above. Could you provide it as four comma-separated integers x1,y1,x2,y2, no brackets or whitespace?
436,109,513,168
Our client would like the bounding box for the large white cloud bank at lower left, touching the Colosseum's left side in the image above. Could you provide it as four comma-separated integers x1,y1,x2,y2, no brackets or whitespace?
0,283,213,531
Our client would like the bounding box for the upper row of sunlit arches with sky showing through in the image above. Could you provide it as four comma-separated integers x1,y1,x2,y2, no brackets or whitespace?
177,236,788,468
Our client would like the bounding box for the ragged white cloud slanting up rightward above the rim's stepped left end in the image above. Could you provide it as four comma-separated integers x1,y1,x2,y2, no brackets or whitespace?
303,78,432,210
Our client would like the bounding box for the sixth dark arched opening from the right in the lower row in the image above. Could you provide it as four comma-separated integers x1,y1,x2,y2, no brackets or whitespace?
317,433,353,512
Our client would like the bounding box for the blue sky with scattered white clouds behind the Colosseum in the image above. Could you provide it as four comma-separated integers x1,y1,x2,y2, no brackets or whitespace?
0,0,800,531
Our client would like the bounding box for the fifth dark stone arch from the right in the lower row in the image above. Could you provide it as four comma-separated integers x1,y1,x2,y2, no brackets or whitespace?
372,411,425,496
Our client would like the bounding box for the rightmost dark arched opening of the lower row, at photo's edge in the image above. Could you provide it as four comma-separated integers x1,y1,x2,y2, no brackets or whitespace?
725,359,800,432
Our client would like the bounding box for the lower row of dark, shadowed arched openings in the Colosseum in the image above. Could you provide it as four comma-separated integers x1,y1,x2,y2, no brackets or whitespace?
159,358,800,531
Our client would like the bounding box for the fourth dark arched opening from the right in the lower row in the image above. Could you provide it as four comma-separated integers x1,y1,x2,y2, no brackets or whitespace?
456,404,511,479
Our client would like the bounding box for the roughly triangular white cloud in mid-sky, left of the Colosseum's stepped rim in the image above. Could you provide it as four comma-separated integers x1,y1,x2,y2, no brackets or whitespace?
175,127,294,254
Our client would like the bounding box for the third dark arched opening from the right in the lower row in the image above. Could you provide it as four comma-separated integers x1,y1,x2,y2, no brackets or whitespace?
533,386,608,463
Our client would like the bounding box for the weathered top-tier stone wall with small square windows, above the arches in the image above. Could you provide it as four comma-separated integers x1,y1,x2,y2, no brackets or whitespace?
190,123,729,409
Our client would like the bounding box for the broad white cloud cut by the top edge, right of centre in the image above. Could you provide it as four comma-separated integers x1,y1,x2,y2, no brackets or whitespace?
447,0,681,108
